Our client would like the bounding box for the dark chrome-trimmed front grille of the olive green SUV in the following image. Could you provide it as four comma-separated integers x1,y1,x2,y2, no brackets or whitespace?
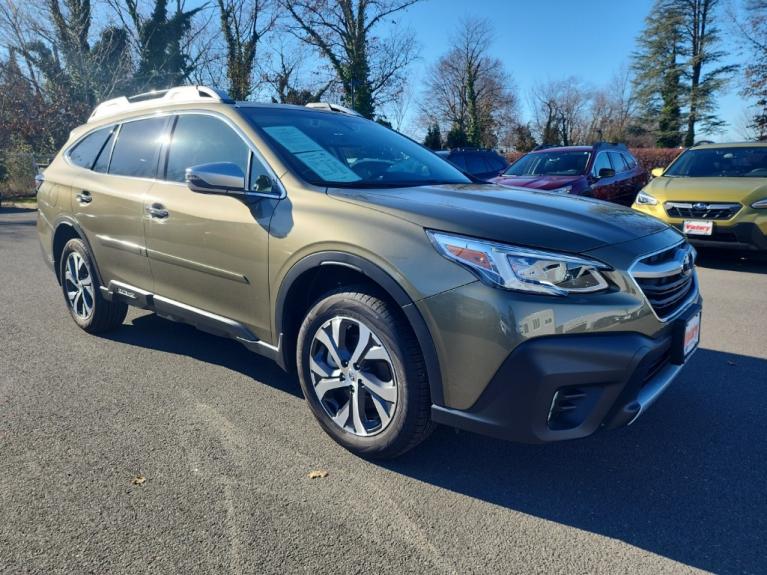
631,243,695,320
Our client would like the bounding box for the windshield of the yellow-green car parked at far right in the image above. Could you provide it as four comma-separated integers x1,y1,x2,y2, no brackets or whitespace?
663,146,767,178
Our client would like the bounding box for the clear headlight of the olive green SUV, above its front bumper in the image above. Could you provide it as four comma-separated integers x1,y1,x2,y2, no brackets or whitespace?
426,231,610,295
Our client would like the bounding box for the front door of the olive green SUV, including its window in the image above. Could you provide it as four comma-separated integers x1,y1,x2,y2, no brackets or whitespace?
144,113,278,341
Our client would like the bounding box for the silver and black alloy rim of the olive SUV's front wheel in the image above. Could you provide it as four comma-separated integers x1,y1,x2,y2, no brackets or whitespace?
309,317,398,436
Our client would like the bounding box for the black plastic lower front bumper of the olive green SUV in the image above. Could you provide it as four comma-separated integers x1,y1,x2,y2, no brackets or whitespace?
432,304,700,443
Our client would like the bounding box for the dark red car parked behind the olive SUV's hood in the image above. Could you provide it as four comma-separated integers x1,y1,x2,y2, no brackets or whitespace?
492,142,649,206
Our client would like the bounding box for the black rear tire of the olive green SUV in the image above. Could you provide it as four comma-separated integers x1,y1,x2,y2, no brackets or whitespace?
59,238,128,333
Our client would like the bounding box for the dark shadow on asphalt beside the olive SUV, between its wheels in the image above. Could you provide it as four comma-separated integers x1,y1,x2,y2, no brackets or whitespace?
102,313,303,398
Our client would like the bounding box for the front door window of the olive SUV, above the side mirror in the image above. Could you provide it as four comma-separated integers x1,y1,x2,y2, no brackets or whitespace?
165,114,249,182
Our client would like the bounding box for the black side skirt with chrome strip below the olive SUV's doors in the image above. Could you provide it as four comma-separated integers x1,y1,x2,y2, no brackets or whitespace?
101,281,285,368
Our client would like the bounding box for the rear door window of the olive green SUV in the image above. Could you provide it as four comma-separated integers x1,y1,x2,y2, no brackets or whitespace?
109,117,166,178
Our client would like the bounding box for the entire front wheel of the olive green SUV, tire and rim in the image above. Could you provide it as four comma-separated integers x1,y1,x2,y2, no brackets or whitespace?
297,290,432,458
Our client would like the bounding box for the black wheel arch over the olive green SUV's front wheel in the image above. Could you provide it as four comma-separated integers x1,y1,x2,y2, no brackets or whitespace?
274,251,444,405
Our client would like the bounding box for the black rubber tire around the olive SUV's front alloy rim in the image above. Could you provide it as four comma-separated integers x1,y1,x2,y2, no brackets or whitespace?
296,288,433,459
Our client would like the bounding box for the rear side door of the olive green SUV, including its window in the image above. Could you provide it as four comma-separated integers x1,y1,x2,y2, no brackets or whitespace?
69,117,167,289
